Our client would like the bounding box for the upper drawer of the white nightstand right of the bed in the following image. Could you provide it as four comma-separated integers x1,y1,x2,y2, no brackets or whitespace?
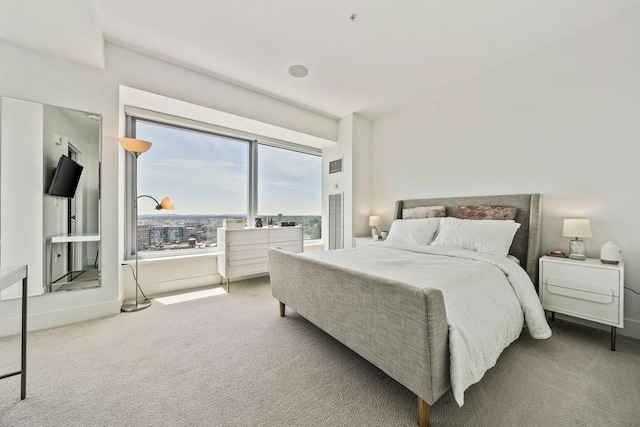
542,262,620,297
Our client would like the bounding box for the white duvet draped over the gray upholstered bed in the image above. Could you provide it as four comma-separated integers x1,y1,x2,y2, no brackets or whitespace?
304,242,551,406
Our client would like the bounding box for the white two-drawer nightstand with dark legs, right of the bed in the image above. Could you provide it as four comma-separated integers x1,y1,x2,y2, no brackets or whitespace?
540,256,624,351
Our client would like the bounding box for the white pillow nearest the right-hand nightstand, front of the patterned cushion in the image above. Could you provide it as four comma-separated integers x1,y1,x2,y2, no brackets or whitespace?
431,217,520,257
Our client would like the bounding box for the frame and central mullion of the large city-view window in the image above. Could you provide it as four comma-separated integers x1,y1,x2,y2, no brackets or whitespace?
124,110,322,261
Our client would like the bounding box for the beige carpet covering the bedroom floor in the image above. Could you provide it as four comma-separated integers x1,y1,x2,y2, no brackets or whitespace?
0,279,640,427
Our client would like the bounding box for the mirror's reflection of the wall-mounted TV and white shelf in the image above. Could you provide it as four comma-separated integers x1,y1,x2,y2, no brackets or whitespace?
43,105,101,292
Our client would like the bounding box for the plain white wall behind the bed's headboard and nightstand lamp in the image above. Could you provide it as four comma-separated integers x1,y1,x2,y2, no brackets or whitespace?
372,14,640,337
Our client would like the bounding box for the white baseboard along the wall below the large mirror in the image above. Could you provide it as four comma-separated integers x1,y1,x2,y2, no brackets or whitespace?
0,301,122,337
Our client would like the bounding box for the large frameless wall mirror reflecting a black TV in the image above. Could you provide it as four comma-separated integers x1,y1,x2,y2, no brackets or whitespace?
0,97,102,299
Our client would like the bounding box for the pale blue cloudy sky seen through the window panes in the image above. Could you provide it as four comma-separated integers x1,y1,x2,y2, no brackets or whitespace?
136,121,322,215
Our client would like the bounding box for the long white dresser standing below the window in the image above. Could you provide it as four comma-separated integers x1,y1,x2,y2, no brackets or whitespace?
218,226,303,292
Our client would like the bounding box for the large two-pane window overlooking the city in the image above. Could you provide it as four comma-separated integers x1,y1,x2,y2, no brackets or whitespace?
125,116,322,257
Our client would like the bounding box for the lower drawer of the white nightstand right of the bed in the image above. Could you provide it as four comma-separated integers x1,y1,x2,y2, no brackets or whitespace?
542,283,620,324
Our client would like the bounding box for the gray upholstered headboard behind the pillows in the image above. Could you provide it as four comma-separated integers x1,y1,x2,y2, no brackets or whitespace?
394,194,540,289
